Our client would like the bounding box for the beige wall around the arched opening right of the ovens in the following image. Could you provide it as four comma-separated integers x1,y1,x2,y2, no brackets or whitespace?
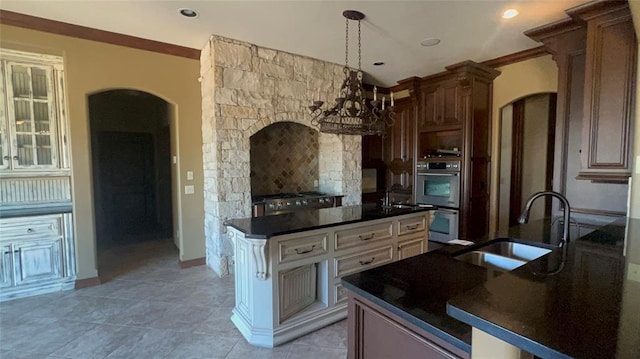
489,55,558,232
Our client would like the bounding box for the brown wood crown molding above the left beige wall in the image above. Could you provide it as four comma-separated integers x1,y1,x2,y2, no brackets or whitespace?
0,10,200,60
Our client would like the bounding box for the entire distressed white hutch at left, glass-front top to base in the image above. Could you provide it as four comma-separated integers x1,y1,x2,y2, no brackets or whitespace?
0,48,76,302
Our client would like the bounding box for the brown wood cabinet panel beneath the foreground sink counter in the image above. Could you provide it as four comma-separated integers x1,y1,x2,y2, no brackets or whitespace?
347,292,470,359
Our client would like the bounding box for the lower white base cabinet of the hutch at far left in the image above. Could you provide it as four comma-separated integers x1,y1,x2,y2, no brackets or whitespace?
0,213,75,300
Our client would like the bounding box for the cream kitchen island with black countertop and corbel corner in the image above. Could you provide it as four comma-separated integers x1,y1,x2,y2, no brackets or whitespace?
225,205,434,347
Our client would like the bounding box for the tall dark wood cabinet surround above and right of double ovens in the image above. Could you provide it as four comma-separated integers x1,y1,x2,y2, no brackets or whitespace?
415,61,500,239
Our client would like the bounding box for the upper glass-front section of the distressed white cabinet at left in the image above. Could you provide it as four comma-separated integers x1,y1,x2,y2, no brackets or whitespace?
0,49,68,173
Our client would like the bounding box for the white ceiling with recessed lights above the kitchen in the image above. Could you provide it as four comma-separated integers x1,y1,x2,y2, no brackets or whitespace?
0,0,587,87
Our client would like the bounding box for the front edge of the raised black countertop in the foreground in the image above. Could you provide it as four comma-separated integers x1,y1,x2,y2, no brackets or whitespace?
447,303,572,359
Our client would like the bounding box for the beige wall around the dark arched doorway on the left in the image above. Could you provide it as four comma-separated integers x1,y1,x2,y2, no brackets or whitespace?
0,25,205,279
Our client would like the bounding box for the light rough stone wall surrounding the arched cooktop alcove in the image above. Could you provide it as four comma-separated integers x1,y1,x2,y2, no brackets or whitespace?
200,36,362,276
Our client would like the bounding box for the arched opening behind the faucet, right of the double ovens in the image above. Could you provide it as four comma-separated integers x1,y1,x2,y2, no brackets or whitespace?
498,93,556,233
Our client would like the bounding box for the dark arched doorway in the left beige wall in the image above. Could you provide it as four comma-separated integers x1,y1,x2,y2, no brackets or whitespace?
89,89,173,280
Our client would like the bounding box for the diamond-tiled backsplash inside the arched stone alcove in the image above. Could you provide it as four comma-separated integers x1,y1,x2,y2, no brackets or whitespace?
250,122,319,196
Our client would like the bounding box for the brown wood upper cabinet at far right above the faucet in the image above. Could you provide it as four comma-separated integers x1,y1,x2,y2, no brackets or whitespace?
525,1,637,183
